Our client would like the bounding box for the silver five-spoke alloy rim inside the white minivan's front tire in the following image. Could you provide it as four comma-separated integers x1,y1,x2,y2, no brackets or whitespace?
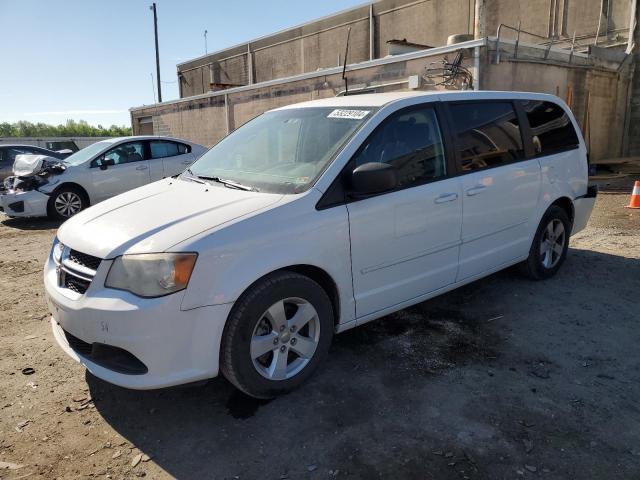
250,298,320,380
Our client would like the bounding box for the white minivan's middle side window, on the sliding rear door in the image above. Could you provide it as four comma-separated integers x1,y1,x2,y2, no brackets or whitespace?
451,102,525,171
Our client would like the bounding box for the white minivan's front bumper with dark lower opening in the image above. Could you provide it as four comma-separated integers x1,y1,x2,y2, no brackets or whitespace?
44,256,232,390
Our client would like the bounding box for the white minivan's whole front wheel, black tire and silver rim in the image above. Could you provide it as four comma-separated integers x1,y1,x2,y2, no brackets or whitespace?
220,271,334,399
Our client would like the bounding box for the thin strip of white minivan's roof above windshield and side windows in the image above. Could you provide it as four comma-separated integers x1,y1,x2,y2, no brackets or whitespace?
275,90,559,110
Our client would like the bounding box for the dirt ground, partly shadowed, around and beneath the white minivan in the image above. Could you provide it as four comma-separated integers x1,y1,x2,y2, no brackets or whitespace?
0,194,640,479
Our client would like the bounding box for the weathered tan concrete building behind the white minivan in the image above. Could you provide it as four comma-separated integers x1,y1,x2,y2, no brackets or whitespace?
131,0,640,160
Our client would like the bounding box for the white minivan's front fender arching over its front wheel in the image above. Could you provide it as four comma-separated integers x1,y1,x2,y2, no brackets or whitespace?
174,194,355,323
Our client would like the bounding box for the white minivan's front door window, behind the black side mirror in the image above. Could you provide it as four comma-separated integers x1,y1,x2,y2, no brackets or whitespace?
353,107,447,187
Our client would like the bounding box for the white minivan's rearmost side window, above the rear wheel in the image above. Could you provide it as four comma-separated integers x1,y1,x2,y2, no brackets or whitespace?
523,101,580,155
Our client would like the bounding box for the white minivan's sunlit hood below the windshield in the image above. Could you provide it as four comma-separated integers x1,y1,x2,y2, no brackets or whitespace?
58,179,283,258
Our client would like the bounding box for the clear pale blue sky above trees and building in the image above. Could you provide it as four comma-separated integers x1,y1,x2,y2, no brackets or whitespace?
0,0,363,127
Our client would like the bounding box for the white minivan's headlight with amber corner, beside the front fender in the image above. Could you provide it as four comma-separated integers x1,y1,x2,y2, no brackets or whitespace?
105,253,198,297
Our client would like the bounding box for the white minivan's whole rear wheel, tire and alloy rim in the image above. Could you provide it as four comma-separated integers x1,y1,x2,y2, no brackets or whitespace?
518,205,571,280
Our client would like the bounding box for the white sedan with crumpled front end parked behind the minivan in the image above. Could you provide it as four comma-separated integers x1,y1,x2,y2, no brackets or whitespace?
0,136,206,220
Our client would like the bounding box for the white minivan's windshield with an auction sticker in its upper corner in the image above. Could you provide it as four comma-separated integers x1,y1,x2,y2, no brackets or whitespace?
188,107,374,193
